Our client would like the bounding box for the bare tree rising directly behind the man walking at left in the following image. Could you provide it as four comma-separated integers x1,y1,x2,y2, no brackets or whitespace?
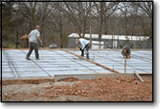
14,2,56,46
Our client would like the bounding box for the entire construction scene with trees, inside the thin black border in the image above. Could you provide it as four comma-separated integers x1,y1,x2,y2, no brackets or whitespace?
0,0,153,102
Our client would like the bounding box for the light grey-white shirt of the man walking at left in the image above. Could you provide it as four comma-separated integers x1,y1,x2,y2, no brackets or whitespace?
28,29,40,44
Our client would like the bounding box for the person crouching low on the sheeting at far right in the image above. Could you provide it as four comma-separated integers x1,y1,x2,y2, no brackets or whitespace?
121,45,131,59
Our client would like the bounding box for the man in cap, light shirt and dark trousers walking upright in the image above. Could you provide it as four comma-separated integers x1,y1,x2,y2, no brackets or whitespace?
21,26,43,60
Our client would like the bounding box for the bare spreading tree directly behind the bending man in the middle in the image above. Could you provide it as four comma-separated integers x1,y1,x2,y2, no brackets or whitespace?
59,2,89,37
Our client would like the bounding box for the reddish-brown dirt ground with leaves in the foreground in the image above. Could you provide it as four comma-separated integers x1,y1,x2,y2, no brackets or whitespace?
2,77,152,101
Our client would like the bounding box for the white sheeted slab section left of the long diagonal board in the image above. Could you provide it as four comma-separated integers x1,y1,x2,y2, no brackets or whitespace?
2,50,112,79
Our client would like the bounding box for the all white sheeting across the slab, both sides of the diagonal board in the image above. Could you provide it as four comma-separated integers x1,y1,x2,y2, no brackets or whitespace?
2,50,152,79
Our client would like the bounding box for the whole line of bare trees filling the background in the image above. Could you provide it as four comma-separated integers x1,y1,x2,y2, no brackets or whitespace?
1,1,152,48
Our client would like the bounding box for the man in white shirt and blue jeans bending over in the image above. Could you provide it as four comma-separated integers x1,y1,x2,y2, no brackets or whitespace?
76,38,90,59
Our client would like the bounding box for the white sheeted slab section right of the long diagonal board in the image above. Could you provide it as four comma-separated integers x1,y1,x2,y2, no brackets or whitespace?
69,50,152,73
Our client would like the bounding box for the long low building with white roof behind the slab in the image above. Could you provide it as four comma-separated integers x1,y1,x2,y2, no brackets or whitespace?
68,33,149,49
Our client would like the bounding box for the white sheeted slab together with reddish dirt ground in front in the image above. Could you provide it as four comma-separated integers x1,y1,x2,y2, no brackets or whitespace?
2,49,152,101
